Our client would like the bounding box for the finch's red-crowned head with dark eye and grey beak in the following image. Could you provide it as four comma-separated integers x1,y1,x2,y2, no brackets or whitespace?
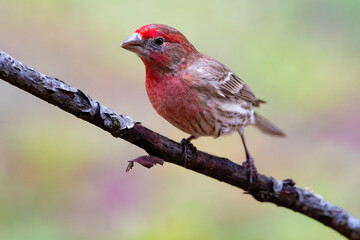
121,24,197,71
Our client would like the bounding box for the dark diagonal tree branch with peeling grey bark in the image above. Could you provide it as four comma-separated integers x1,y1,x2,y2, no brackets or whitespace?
0,50,360,239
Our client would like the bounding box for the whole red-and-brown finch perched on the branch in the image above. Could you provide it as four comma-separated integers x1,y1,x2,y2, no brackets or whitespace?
121,24,284,182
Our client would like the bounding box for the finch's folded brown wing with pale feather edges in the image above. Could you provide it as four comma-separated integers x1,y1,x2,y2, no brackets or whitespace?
194,56,265,106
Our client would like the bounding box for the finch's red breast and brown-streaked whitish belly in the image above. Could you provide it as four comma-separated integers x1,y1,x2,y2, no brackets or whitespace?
146,78,254,137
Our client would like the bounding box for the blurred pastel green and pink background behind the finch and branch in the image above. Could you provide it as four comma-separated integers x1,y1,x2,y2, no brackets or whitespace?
0,0,360,240
